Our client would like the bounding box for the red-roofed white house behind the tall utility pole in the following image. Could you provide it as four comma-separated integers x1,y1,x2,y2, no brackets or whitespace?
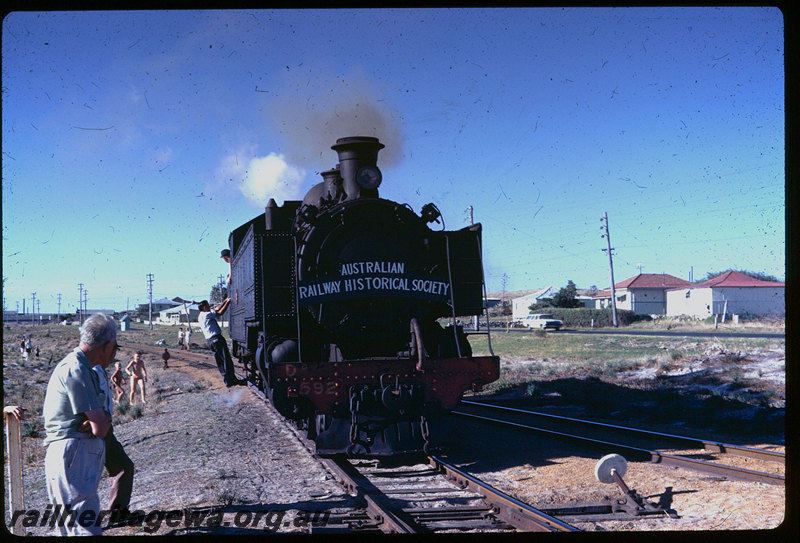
594,273,691,315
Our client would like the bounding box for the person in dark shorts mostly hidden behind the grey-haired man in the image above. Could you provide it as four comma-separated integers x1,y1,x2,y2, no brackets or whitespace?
92,348,134,520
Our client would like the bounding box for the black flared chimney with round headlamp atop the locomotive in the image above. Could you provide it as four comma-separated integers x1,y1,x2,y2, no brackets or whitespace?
331,136,385,200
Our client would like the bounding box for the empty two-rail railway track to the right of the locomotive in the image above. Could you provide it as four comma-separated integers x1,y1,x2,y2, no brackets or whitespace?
452,401,785,485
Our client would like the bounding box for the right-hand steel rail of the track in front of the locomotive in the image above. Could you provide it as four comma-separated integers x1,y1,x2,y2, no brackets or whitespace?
429,456,579,532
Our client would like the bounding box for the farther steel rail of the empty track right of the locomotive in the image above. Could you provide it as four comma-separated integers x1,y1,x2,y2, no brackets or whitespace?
461,400,786,464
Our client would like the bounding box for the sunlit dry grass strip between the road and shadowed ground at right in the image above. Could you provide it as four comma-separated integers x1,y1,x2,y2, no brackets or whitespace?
470,323,785,406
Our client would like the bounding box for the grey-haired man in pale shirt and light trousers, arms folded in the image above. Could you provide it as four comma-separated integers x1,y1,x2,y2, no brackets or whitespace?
42,314,119,535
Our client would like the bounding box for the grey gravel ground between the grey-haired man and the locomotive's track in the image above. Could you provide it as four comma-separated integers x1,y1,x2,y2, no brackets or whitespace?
5,348,356,535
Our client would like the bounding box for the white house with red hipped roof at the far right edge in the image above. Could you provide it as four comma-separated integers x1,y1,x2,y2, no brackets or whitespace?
667,271,786,318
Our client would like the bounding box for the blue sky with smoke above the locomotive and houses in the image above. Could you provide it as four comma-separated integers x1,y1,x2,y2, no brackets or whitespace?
2,7,786,312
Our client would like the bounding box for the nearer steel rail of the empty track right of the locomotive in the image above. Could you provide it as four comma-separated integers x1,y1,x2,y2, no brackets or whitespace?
452,411,786,485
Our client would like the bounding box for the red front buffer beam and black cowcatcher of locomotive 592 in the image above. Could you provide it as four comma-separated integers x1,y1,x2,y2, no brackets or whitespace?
270,356,499,457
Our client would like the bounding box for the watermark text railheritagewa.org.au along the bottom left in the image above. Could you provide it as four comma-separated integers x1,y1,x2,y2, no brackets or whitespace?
10,504,330,533
